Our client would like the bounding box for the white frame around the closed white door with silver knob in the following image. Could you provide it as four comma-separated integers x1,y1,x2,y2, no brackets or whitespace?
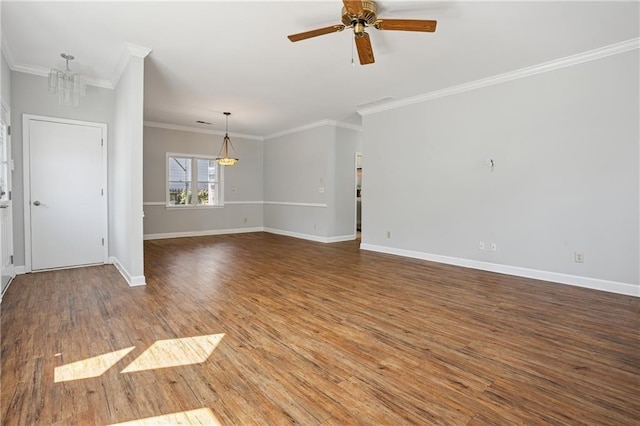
22,114,109,272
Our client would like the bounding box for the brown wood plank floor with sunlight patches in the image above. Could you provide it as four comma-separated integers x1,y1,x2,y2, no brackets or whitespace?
0,233,640,426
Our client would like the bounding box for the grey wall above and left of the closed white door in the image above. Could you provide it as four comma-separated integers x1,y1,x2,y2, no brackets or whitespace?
11,71,114,267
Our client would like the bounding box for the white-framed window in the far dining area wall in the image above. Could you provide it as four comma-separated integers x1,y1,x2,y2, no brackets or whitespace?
167,154,222,206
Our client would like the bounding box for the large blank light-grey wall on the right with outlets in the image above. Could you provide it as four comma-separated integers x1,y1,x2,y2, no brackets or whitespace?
362,50,640,295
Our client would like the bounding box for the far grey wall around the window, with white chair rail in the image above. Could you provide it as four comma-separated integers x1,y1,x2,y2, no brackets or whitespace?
143,126,263,238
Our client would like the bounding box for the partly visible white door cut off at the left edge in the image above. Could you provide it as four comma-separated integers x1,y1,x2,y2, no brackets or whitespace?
0,105,15,293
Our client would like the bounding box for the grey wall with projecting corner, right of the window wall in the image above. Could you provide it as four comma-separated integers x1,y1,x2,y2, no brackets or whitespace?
264,122,362,242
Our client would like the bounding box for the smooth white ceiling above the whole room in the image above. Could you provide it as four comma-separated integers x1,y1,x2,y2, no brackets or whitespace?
1,0,640,136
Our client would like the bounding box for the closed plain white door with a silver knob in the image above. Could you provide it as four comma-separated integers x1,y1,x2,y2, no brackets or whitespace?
25,118,107,271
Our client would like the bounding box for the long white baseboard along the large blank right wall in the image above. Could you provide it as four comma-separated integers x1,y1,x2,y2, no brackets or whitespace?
360,244,640,297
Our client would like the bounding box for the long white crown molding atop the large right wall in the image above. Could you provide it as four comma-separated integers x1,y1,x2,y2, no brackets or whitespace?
357,38,640,116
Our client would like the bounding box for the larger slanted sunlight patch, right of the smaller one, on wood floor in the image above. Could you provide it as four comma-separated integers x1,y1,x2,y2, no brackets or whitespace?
122,333,224,373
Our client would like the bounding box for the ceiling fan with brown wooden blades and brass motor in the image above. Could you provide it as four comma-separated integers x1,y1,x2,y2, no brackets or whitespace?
288,0,437,65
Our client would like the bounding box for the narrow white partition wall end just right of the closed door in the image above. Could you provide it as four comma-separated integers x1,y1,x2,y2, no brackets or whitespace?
109,51,148,285
